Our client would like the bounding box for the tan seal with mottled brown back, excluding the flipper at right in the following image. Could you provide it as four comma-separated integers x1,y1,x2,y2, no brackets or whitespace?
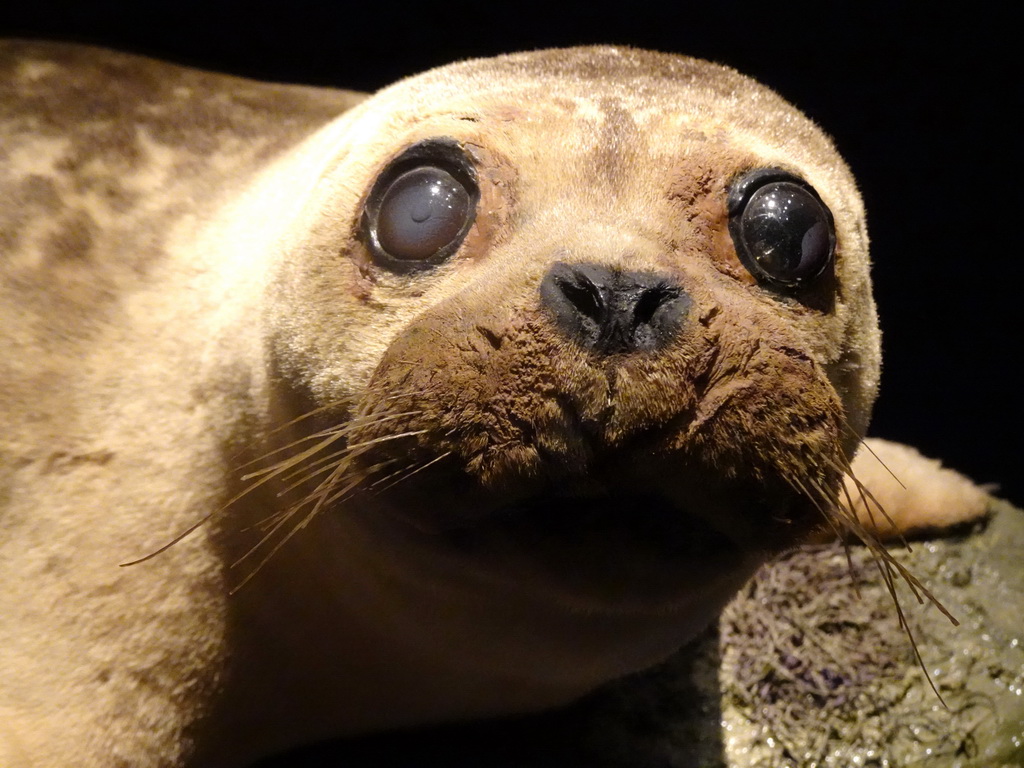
0,42,987,768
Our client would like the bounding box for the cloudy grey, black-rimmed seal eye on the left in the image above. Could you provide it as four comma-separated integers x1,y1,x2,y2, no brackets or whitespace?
362,139,479,271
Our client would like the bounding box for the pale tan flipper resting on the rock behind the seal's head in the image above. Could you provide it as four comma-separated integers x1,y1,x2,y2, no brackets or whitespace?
844,437,990,539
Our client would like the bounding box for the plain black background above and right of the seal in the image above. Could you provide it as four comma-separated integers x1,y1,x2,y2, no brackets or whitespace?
0,0,1024,505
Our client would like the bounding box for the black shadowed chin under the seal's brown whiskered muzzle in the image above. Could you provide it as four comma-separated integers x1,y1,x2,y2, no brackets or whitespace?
356,475,796,618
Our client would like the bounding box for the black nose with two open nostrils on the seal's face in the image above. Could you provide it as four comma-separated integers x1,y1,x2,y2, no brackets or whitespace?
541,261,690,354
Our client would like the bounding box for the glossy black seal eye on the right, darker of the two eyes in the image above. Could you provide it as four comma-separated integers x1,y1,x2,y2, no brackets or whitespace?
729,168,836,288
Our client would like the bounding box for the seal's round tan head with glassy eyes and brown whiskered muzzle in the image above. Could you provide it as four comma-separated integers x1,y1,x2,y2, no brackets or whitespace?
239,48,879,733
